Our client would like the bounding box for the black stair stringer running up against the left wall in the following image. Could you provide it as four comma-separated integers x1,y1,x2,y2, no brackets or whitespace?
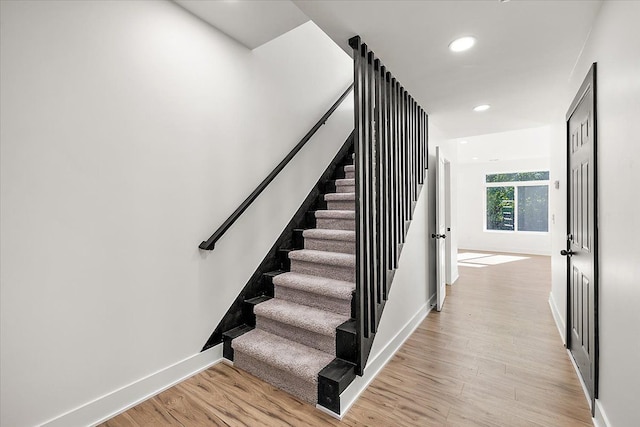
201,132,353,351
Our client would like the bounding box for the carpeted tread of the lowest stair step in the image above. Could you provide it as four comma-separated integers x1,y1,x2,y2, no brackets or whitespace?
231,329,334,383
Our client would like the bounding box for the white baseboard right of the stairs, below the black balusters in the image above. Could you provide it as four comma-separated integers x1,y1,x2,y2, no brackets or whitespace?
332,295,436,419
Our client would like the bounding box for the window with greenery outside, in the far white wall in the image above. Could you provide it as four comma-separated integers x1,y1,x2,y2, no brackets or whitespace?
485,171,549,232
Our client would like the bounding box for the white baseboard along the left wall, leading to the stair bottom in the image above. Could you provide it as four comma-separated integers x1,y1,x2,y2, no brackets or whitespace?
42,344,222,427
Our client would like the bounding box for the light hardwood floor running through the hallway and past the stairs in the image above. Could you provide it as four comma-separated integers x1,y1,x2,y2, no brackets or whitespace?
103,251,592,427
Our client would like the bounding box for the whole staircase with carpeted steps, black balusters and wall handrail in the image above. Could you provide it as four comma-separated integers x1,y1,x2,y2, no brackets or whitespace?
199,36,428,414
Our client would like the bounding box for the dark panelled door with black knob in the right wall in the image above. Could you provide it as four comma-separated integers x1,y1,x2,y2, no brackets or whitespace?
562,64,598,407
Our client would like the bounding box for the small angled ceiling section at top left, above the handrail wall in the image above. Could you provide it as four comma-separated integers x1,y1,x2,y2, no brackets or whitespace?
174,0,309,49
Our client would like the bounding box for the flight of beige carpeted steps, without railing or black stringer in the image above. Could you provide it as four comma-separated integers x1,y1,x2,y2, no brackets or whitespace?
229,155,356,405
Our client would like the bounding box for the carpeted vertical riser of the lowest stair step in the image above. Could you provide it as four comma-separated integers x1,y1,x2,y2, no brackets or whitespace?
233,351,318,405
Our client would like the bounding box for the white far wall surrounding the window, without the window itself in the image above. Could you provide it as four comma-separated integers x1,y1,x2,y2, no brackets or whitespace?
453,127,556,255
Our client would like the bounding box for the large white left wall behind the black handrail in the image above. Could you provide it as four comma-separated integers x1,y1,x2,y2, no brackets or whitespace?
0,1,353,427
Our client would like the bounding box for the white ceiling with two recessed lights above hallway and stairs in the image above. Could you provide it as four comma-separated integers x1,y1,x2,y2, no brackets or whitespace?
176,0,602,138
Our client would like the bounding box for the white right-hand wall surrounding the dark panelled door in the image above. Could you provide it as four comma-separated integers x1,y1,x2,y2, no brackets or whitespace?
552,1,640,427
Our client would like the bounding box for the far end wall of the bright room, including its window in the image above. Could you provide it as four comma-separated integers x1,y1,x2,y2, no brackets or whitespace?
456,127,555,255
